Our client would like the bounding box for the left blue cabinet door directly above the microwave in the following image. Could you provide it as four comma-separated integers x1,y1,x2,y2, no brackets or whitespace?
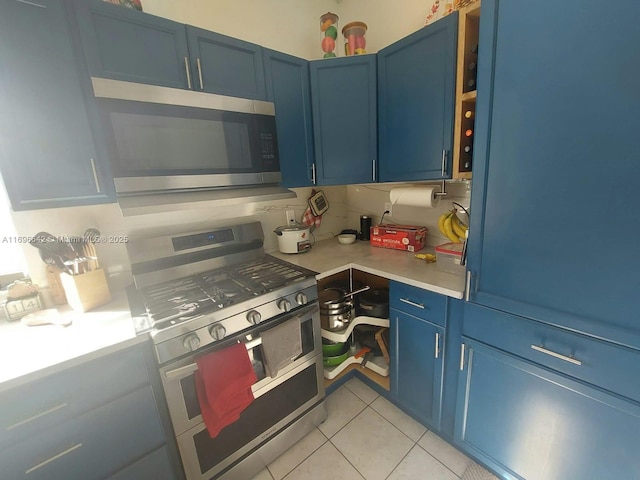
73,0,193,88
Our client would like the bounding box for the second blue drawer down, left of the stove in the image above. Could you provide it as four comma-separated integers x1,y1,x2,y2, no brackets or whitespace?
0,386,164,480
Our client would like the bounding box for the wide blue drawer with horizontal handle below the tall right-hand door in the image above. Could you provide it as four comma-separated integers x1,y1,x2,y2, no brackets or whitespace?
463,303,640,402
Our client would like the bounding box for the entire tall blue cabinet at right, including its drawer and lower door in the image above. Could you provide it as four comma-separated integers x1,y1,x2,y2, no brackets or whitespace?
455,0,640,480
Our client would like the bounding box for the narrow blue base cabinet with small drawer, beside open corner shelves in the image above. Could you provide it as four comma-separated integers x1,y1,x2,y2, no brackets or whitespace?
389,281,447,431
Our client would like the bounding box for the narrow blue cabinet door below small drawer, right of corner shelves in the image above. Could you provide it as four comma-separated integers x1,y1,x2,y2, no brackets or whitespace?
390,308,444,430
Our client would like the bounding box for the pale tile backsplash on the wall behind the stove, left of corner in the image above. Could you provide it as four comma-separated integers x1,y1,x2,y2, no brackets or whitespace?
12,186,347,290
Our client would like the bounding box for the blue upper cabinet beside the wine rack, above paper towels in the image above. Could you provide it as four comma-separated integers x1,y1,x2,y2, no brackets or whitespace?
378,12,458,182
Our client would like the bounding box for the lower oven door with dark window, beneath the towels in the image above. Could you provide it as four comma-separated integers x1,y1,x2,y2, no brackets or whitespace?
177,354,324,480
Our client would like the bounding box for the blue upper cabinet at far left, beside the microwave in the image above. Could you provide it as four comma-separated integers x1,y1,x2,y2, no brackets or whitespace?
0,0,113,210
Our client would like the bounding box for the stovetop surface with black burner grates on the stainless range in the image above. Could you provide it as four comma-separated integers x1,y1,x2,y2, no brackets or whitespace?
141,255,309,329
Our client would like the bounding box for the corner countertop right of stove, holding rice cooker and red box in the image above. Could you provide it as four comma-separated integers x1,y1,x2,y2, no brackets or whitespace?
271,238,464,298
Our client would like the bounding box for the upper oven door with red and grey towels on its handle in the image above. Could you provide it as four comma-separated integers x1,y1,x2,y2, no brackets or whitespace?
160,303,322,435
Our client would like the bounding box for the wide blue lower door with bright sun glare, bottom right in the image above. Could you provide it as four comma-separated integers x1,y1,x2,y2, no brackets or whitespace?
455,337,640,480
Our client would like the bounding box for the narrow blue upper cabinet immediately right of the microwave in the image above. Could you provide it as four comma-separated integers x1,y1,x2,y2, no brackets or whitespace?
264,49,314,187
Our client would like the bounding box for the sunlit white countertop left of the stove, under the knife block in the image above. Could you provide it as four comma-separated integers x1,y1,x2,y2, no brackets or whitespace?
0,292,141,391
